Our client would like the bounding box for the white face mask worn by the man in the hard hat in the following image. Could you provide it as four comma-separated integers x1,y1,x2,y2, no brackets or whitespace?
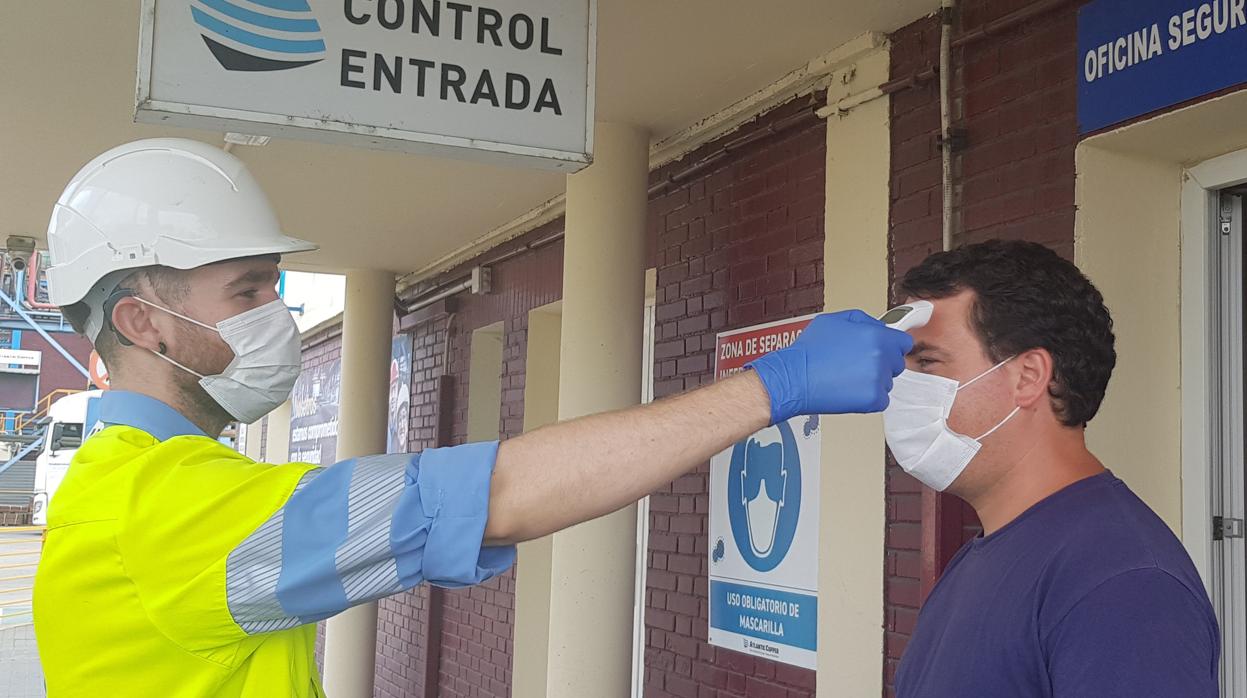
133,295,303,424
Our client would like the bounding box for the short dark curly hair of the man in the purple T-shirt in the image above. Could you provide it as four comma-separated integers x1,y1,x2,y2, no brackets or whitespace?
897,241,1117,426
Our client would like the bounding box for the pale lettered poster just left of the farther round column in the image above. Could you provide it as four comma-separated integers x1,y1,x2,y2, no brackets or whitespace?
291,359,342,465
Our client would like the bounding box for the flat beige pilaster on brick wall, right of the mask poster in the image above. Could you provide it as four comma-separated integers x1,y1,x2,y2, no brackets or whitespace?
818,43,890,697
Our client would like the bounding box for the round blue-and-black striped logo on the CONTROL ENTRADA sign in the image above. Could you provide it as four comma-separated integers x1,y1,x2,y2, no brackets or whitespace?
191,0,325,72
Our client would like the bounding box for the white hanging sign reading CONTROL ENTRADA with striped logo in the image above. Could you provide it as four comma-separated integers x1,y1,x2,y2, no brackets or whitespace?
136,0,596,172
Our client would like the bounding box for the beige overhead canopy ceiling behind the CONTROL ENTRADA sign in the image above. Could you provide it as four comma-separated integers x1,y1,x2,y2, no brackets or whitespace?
0,0,936,273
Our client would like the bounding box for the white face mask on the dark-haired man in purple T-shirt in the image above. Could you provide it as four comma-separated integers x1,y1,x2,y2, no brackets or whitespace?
883,356,1021,492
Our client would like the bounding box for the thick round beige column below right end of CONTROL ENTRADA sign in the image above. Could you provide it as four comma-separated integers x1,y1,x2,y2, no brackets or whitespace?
546,123,650,698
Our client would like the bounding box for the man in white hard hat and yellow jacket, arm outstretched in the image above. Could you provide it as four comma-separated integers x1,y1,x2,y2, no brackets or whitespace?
35,140,912,698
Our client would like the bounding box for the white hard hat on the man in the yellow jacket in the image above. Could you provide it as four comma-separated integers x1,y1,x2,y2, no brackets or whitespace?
47,138,317,310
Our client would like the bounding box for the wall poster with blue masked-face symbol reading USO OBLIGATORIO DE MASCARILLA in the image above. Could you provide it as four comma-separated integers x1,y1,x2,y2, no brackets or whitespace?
710,315,822,669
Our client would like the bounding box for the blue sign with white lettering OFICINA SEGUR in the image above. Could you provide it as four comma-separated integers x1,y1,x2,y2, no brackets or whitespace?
1079,0,1247,133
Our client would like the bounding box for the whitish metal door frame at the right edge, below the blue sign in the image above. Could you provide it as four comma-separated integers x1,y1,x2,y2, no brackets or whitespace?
1181,151,1247,698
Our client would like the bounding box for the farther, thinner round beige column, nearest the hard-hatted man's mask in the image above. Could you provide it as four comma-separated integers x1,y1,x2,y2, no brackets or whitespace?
324,270,394,698
